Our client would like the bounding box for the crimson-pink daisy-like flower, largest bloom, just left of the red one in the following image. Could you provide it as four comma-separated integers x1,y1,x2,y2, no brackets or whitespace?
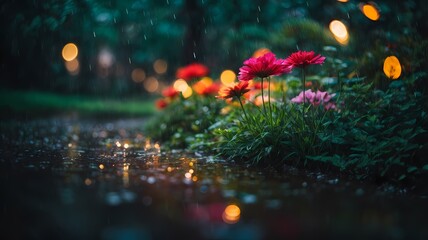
238,52,291,81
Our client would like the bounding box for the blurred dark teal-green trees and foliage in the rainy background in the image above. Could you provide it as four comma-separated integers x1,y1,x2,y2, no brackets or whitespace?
0,0,428,95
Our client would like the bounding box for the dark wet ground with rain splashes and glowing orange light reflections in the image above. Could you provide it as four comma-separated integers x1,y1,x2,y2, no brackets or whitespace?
0,117,428,240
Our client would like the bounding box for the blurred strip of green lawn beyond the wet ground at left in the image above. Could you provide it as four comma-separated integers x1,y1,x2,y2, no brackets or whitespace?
0,89,155,118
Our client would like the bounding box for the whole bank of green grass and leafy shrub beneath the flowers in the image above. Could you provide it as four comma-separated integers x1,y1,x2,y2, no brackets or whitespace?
214,74,428,180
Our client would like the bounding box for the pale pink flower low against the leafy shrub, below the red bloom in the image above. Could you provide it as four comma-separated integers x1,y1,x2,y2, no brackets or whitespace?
291,89,336,110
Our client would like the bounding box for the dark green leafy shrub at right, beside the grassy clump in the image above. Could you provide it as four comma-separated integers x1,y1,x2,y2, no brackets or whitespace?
318,83,426,179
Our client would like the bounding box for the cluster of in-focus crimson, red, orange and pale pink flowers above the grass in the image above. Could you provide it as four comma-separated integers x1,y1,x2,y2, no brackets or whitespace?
217,51,336,110
